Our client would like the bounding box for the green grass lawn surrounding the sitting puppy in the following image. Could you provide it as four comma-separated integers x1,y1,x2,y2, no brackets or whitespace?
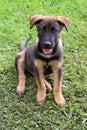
0,0,87,130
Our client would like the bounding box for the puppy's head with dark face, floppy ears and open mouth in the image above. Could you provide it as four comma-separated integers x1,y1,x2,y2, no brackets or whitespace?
30,15,69,55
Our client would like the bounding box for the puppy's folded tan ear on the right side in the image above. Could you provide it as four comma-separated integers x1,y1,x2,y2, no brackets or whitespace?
57,16,70,31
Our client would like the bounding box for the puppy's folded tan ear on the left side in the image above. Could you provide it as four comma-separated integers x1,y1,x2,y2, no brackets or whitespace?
30,15,43,29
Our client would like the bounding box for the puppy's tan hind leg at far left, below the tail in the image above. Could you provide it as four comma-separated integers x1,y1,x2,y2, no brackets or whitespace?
16,51,26,96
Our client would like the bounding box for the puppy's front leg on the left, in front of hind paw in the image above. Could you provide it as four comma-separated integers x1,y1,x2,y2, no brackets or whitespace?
35,60,46,104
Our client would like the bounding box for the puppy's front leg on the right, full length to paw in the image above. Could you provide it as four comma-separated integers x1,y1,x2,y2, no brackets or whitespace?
52,62,66,106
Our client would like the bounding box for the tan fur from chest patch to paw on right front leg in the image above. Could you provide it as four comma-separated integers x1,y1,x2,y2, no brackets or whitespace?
50,60,66,106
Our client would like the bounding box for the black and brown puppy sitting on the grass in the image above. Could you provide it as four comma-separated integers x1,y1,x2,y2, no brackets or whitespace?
15,15,69,105
